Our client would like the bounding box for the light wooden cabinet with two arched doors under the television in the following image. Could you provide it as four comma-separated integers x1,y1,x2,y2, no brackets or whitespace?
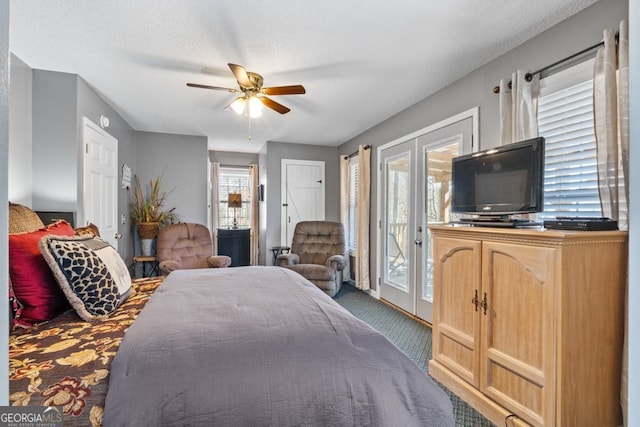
429,226,627,426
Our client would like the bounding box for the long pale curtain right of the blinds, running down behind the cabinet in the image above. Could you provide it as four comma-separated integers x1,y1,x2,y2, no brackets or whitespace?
593,20,629,426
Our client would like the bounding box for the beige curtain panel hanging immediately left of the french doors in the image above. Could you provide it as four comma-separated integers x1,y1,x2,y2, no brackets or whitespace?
355,145,371,290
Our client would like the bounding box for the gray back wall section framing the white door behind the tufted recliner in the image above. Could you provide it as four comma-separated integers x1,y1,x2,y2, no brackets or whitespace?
260,142,340,263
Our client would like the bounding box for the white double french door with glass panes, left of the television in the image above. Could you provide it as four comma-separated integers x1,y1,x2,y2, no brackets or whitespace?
379,117,474,322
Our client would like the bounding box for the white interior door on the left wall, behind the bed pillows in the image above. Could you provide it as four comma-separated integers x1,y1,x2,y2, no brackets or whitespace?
80,117,120,250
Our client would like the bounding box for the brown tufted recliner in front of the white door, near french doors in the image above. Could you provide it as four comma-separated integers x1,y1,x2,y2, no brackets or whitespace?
276,221,346,297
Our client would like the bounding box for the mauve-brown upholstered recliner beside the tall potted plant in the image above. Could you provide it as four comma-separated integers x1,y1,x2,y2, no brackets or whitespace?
157,223,231,275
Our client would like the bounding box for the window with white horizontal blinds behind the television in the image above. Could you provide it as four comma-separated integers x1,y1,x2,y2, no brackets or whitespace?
538,60,602,220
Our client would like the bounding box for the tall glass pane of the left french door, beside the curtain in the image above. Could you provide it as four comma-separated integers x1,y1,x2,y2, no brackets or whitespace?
385,154,410,289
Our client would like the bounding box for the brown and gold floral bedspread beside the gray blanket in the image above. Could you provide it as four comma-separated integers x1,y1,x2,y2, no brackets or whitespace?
9,278,162,426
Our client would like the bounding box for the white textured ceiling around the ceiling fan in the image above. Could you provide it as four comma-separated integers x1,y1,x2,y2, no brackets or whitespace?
9,0,595,152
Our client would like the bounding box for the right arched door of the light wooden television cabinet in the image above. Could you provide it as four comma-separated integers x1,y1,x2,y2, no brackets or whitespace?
480,242,556,425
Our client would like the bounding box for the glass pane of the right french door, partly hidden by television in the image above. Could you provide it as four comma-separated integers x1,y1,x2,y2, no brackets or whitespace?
422,141,461,302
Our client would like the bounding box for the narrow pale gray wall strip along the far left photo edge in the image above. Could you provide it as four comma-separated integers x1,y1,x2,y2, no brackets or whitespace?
0,1,9,406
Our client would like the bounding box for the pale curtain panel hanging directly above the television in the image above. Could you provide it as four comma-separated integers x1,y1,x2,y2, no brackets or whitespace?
499,70,540,145
